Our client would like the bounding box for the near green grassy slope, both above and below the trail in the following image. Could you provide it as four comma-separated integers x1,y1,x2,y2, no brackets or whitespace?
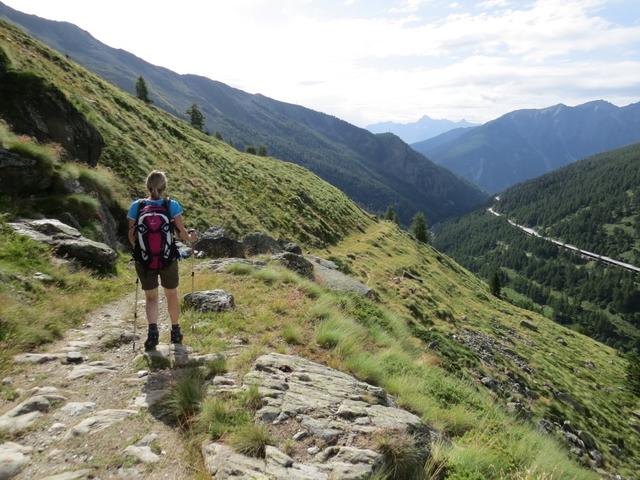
0,16,639,478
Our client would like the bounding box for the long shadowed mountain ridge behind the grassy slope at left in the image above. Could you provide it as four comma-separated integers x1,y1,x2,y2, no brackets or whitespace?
0,4,484,224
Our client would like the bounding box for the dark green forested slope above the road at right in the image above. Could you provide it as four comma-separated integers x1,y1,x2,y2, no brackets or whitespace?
496,144,640,265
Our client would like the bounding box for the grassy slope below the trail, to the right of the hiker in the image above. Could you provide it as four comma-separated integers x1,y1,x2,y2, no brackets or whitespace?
175,222,638,479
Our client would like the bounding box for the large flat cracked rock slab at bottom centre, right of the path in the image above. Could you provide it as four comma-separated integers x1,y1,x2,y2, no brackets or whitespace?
202,353,430,480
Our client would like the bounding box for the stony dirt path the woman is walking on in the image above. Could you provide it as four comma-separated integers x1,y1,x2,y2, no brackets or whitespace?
0,295,202,480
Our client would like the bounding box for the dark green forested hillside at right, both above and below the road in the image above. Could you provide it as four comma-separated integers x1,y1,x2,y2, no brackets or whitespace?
435,145,640,350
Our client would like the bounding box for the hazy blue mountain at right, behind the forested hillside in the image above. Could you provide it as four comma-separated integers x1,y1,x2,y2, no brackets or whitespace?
412,100,640,193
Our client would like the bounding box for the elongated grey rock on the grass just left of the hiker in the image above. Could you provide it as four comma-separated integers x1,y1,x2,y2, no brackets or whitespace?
9,219,117,273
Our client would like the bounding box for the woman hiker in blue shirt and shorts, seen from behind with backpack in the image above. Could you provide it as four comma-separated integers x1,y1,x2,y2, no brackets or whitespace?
127,170,198,351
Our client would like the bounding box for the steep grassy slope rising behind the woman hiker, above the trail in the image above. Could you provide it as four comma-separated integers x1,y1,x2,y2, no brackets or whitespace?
0,21,370,245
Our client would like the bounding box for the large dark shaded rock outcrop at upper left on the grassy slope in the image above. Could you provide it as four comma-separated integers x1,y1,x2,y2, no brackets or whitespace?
0,62,104,166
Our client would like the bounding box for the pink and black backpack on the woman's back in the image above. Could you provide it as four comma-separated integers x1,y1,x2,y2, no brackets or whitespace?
134,198,178,270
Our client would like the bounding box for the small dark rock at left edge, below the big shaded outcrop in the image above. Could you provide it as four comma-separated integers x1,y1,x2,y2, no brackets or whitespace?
0,148,53,194
